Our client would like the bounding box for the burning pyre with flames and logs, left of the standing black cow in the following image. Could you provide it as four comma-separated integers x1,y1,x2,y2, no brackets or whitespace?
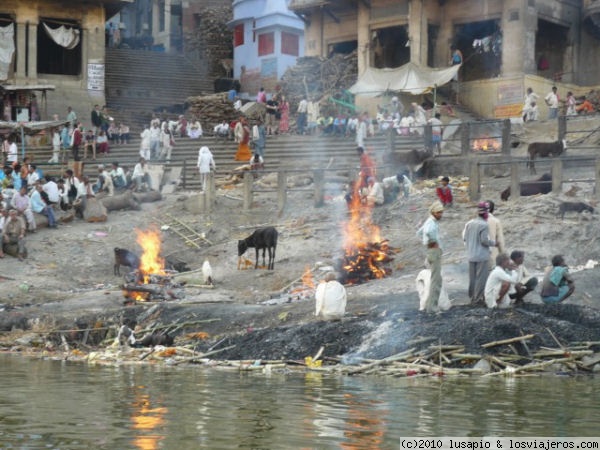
123,228,184,302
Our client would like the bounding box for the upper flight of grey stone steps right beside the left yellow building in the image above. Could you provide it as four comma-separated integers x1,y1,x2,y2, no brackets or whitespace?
106,48,213,130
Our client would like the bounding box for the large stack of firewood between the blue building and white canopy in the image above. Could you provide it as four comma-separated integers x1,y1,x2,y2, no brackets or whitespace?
281,51,358,111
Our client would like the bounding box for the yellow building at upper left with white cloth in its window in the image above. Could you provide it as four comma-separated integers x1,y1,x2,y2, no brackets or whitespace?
0,0,124,124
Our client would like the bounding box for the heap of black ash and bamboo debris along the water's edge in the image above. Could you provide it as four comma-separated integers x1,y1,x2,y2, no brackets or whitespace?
7,303,600,377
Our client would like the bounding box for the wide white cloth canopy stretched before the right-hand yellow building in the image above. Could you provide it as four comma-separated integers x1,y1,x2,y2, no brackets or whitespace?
349,62,460,96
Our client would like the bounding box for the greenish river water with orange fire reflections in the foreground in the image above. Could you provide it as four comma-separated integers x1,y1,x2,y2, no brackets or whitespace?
0,355,600,450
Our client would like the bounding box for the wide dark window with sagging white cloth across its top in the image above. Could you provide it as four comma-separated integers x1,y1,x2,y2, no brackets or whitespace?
37,18,82,75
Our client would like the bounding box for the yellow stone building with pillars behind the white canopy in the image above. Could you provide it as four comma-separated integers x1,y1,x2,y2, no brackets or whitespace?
289,0,600,117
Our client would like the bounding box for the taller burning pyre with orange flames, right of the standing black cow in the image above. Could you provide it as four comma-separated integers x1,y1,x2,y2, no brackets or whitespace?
338,193,396,284
